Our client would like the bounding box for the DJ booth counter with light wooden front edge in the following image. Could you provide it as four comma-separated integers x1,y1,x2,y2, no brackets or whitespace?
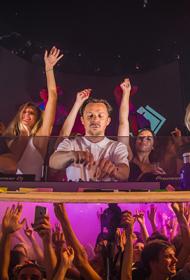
0,181,190,203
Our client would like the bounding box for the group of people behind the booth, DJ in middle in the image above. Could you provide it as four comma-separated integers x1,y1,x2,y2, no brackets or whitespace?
0,47,190,181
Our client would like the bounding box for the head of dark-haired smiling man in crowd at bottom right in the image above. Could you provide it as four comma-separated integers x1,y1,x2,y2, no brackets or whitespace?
141,240,177,279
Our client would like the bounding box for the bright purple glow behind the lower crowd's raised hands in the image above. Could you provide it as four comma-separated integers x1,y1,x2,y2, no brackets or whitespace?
0,201,172,247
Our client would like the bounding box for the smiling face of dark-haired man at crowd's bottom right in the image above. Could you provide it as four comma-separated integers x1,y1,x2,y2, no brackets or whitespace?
150,247,177,277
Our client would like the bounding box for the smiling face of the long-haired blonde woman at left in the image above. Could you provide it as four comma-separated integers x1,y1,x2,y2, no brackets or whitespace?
20,106,37,130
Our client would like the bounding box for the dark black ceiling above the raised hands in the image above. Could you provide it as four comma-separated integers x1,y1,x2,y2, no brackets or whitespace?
0,0,190,75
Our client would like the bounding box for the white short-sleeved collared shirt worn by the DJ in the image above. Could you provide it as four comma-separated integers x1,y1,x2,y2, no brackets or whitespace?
57,137,129,181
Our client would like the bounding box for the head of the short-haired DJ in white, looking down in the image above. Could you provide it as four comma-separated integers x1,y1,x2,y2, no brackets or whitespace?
81,103,111,136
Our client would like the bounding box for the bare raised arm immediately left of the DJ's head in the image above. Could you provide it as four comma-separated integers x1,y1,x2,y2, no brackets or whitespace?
59,88,91,136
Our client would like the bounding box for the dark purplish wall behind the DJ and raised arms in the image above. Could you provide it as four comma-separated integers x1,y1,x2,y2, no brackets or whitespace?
0,48,184,135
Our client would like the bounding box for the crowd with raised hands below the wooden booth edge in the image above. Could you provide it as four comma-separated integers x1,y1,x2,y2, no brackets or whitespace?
0,203,190,280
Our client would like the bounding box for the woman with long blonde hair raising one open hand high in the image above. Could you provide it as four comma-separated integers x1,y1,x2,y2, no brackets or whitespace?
4,47,63,180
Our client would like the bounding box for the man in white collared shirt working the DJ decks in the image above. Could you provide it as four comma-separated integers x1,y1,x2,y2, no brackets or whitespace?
49,99,129,181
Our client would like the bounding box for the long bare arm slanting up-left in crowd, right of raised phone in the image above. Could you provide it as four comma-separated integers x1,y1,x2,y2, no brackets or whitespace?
54,203,102,280
